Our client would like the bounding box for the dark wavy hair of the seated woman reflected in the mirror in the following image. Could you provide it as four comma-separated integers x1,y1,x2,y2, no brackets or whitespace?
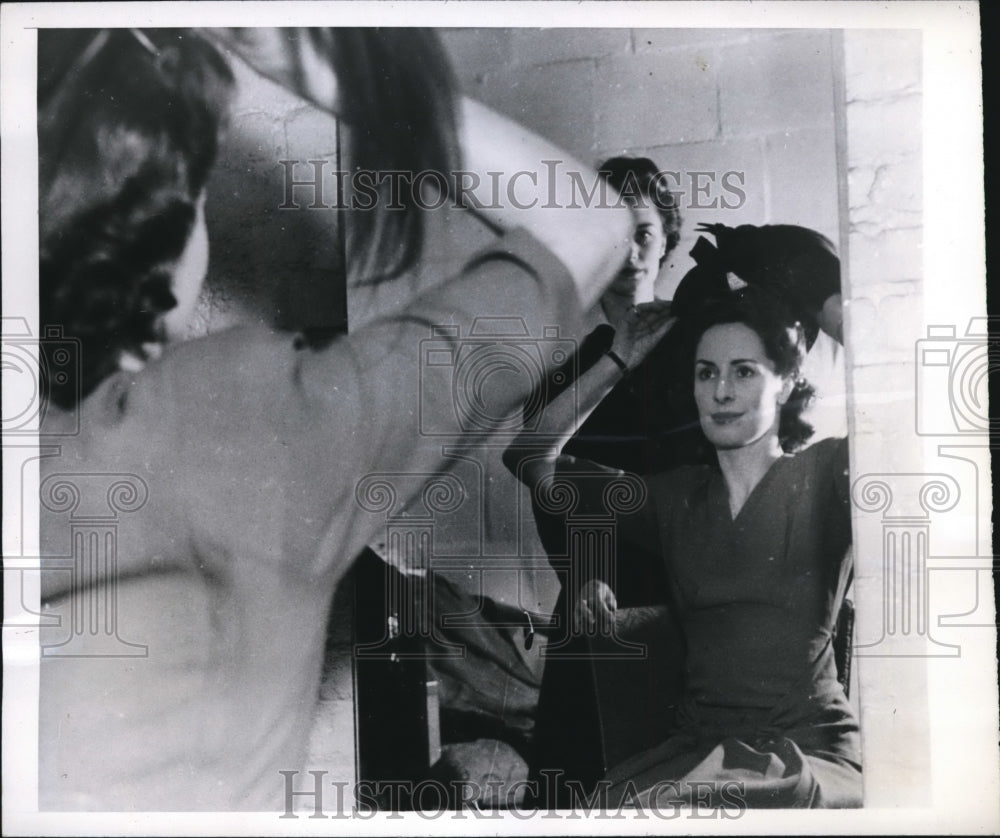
679,286,816,460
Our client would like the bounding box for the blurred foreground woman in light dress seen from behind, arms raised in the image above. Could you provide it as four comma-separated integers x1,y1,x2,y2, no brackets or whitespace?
38,29,630,811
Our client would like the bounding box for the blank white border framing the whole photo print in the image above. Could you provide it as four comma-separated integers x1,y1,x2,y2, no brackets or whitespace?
0,0,1000,835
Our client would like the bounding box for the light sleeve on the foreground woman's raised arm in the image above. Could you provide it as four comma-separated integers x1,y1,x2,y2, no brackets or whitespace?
160,230,582,571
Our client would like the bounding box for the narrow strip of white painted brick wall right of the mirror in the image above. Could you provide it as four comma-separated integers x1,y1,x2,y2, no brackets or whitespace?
843,30,933,806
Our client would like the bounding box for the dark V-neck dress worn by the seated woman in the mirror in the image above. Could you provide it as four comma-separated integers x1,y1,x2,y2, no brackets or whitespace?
559,440,861,807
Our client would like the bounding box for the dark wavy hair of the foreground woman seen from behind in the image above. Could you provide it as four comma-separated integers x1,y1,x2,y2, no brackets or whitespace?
38,29,233,407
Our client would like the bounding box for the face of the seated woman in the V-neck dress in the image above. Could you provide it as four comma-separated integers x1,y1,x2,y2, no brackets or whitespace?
694,323,793,449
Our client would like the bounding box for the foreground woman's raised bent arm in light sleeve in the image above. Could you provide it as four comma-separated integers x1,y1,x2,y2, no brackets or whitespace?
190,30,632,576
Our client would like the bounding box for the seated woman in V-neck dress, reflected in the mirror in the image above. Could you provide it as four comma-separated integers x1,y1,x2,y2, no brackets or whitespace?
506,233,861,807
